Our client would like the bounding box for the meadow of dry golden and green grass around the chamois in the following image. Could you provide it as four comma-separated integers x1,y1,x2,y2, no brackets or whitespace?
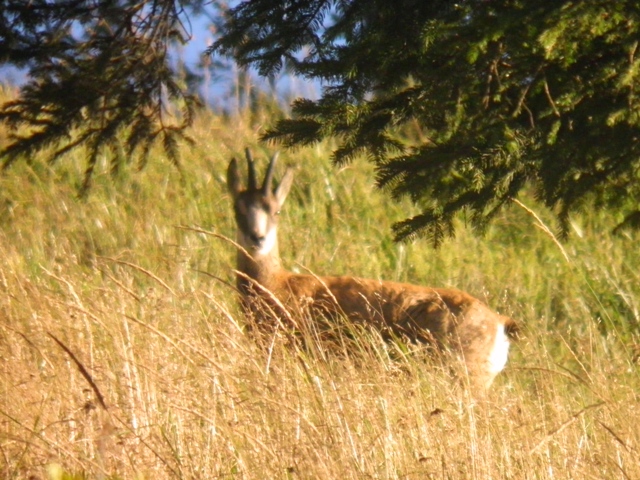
0,84,640,480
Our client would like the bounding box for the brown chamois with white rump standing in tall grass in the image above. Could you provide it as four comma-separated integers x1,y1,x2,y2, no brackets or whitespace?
227,149,516,388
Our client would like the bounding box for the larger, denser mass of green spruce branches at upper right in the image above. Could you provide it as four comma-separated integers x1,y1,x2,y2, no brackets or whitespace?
210,0,640,245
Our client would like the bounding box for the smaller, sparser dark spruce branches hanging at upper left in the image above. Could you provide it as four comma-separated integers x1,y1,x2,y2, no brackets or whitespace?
0,0,207,190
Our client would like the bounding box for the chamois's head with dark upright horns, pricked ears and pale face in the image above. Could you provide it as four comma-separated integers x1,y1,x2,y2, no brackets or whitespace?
227,149,293,255
